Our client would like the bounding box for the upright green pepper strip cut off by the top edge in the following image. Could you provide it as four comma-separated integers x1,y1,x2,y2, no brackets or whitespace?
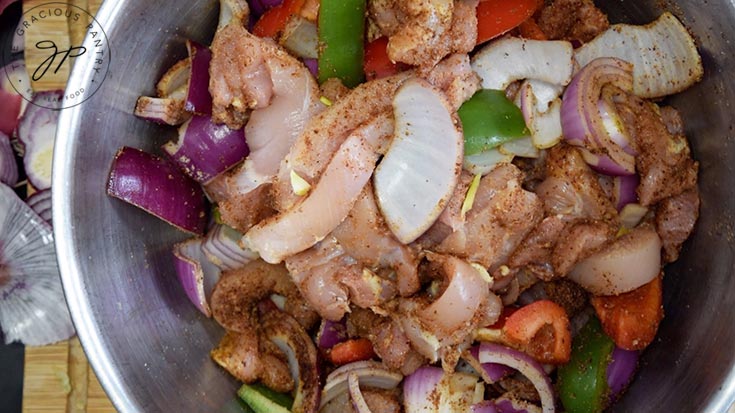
318,0,367,87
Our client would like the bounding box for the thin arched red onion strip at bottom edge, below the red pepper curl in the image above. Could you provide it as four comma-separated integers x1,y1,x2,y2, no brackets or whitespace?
478,343,556,413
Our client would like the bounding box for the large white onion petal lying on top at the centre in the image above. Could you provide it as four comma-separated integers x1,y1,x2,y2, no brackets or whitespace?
374,79,464,244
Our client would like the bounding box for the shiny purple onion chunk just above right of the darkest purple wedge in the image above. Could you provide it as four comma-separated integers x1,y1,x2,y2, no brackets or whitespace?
163,115,250,185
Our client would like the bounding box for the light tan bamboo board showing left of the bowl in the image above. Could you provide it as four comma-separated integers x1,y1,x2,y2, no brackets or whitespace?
22,0,116,413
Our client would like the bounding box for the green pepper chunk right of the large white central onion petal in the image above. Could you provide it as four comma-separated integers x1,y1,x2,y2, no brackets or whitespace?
457,89,530,155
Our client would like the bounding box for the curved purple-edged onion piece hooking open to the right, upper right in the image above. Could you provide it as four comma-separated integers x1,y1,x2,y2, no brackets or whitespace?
561,58,635,175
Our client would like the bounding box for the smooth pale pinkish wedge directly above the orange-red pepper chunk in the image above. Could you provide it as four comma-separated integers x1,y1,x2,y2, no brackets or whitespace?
567,227,661,295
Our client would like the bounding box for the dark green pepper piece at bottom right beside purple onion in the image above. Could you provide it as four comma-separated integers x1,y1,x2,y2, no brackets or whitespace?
558,317,615,413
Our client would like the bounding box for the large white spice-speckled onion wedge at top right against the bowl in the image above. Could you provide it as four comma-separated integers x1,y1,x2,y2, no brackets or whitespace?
575,12,704,98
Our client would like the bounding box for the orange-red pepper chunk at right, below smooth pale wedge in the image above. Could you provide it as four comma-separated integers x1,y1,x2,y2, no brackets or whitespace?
591,276,664,350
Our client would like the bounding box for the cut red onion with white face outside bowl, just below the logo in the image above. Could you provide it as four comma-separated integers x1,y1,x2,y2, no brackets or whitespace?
18,90,64,190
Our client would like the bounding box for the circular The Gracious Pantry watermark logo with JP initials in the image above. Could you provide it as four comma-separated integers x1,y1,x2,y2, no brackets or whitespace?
3,2,110,109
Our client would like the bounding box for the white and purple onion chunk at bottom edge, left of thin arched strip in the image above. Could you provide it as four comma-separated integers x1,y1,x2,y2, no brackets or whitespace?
403,366,477,413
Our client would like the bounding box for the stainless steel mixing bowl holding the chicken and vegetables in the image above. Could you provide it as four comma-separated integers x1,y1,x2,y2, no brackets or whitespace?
53,0,735,413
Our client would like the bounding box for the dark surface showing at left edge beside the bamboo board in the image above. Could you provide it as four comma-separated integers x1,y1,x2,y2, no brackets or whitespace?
0,1,25,413
